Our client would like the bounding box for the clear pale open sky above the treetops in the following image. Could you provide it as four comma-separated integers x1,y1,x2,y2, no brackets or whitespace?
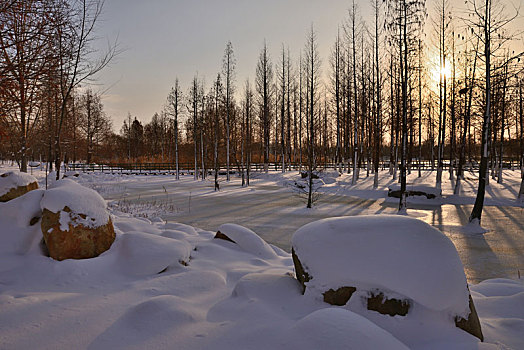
96,0,372,131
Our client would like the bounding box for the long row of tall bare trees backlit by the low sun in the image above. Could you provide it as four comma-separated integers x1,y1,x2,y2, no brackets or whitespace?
0,0,524,222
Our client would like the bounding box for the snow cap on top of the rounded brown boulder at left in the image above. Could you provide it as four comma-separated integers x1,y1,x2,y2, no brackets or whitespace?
40,179,109,228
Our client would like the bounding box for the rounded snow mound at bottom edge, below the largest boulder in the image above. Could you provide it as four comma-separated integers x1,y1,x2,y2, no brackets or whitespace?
282,308,408,350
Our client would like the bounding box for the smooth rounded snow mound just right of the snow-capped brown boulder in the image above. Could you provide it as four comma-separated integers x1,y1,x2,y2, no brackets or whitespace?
116,231,191,276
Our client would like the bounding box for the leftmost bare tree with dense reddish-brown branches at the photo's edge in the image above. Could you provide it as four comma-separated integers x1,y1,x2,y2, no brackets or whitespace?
0,0,51,172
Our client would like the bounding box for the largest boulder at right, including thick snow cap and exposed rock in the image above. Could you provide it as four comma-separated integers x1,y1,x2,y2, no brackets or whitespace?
292,215,483,340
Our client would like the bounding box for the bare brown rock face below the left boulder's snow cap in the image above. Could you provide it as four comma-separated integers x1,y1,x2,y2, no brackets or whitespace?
41,207,115,260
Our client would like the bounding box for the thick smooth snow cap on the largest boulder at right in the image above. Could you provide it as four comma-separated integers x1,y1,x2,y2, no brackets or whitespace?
292,215,469,316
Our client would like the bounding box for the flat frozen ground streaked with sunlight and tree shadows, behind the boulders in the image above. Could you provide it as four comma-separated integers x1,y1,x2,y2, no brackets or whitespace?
75,167,524,283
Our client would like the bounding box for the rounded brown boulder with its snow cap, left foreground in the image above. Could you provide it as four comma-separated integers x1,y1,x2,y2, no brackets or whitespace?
40,179,115,260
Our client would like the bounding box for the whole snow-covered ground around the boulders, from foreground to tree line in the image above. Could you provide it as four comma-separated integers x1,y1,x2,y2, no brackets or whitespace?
0,166,524,349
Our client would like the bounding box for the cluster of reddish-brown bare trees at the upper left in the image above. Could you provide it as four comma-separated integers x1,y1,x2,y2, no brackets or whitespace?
0,0,117,178
